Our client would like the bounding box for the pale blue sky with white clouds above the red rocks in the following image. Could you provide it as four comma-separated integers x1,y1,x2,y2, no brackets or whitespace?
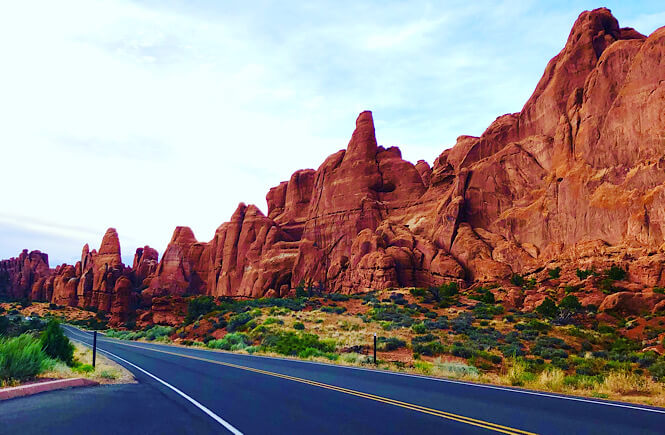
0,0,665,267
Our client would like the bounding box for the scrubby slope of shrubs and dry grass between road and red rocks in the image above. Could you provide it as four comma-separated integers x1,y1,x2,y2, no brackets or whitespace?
9,266,665,406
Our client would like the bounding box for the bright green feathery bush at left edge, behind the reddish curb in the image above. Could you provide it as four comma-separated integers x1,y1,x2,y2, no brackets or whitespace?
0,334,54,381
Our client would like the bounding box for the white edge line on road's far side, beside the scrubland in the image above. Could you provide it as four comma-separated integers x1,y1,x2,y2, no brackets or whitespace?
63,328,665,414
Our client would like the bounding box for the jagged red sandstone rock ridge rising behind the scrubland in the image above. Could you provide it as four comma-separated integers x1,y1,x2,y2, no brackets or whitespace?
0,8,665,322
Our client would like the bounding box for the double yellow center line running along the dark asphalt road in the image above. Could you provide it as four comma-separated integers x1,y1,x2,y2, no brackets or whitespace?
106,341,536,435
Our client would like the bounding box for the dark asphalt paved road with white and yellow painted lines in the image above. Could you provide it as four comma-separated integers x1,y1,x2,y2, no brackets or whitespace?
0,326,665,434
